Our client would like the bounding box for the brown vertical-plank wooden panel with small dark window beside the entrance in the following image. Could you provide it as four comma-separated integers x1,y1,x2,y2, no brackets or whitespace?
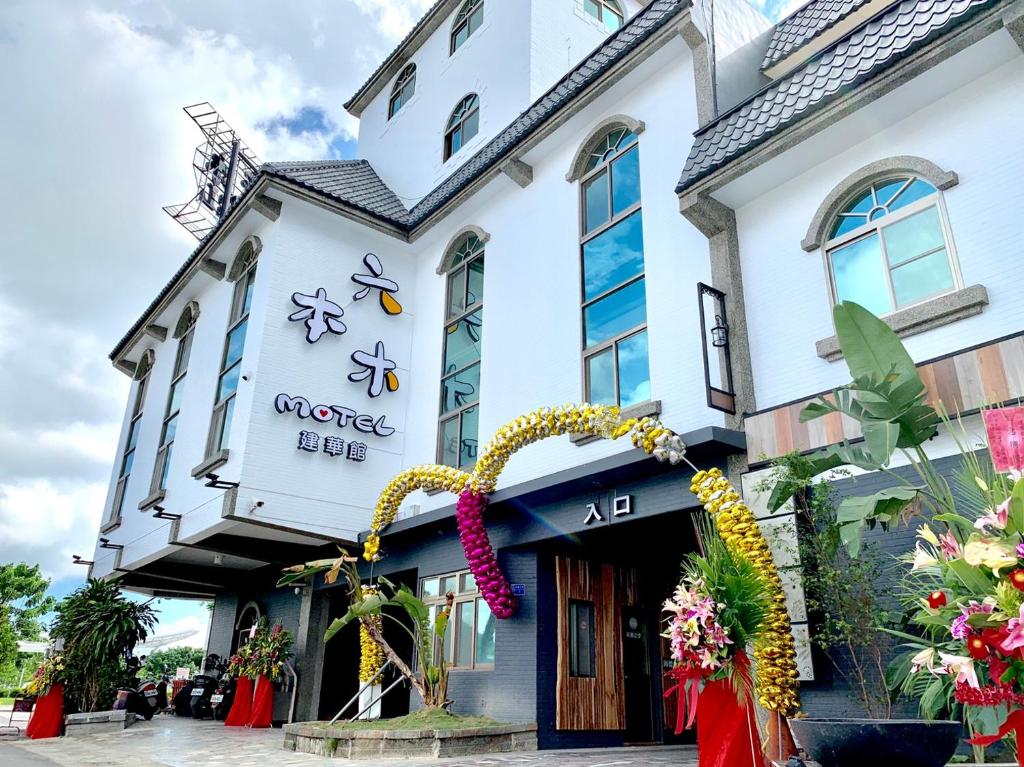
555,556,626,730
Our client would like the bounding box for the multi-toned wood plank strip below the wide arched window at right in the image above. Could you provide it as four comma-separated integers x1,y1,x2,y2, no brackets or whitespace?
743,334,1024,464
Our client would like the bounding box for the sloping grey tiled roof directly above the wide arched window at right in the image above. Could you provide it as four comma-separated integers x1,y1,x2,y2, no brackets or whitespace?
676,0,999,193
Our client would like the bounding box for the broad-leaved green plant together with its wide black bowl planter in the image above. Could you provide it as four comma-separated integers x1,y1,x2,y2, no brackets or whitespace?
769,302,961,767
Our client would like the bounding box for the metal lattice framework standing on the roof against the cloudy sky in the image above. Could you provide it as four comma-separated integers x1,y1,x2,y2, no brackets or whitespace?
164,101,260,240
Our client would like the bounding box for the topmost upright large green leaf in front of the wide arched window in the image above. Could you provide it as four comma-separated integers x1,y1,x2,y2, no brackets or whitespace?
833,301,918,381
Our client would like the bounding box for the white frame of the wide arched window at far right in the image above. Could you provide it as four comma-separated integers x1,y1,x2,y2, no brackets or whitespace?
821,176,964,317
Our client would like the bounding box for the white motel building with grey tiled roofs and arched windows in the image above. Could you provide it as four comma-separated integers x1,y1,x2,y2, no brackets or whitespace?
92,0,1024,747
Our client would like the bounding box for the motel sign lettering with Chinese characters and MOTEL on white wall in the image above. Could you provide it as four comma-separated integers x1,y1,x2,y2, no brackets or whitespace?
282,253,402,463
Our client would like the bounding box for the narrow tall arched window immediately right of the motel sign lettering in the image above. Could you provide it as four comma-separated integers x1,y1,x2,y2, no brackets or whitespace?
437,233,483,466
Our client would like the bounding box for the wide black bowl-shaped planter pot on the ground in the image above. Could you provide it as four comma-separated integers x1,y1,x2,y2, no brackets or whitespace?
790,719,963,767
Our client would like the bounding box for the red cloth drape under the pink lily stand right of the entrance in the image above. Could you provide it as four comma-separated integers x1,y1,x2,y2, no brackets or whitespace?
697,652,765,767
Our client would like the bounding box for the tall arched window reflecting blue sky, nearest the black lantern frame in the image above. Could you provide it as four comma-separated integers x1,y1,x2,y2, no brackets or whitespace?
581,128,650,408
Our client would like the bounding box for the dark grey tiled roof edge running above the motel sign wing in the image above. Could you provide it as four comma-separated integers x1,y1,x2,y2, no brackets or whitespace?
110,0,690,359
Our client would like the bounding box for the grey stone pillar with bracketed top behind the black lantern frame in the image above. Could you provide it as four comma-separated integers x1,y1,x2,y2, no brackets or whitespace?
679,194,757,429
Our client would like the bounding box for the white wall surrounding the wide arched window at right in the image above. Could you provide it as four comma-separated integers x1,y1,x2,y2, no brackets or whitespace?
716,37,1024,409
